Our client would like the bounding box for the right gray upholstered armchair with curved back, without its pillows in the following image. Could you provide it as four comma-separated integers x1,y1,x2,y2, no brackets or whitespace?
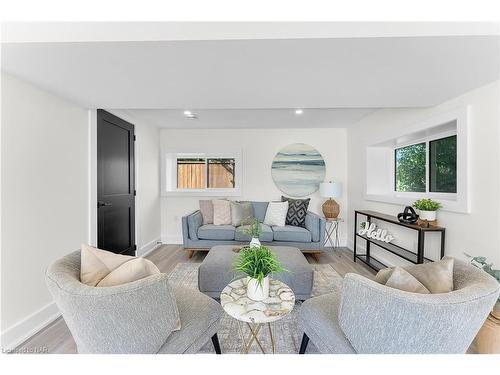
300,259,500,354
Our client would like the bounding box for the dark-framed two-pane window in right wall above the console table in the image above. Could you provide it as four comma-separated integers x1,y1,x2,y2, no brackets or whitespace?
394,135,457,193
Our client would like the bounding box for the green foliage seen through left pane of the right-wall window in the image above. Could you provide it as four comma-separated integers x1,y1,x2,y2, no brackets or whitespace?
395,143,426,192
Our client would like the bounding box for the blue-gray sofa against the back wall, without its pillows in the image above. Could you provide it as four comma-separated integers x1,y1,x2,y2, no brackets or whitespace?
182,202,325,250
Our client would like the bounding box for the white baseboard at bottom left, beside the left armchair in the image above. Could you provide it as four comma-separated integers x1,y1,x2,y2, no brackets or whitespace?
2,302,61,352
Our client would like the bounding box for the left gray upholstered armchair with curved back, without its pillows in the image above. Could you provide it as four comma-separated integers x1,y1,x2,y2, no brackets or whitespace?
46,251,223,354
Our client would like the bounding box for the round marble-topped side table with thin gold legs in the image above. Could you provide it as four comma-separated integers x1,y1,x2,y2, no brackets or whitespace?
220,277,295,354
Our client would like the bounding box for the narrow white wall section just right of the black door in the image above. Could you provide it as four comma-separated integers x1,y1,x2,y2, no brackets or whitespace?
132,120,161,255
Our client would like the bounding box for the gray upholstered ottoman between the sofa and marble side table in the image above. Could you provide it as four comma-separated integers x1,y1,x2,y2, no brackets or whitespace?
198,245,313,300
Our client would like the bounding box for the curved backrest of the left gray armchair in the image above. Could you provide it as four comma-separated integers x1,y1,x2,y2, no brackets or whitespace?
46,251,179,353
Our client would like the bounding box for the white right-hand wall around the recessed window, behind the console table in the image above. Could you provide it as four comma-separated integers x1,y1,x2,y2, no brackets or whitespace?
347,82,500,265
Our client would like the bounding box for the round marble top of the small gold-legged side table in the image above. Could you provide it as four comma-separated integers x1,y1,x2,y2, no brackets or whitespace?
220,277,295,323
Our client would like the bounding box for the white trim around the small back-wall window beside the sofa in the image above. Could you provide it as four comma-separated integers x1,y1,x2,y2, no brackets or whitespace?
161,151,243,197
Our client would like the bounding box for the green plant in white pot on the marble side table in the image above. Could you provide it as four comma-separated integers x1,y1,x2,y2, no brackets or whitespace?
233,246,286,301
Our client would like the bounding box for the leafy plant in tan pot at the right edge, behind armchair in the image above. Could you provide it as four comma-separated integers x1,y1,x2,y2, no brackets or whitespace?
465,254,500,354
